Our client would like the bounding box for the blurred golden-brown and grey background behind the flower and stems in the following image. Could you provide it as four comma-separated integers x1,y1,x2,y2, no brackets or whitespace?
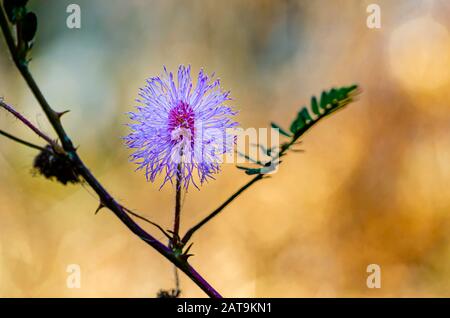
0,0,450,297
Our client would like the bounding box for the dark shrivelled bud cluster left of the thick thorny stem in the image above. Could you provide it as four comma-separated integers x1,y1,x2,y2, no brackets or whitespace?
33,145,80,185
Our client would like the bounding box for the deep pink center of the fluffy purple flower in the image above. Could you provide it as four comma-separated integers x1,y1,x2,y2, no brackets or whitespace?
169,101,195,143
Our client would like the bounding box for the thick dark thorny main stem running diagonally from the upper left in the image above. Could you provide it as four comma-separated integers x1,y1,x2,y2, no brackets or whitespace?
0,4,222,298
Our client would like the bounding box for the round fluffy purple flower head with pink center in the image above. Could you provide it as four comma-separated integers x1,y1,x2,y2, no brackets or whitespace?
124,66,237,189
